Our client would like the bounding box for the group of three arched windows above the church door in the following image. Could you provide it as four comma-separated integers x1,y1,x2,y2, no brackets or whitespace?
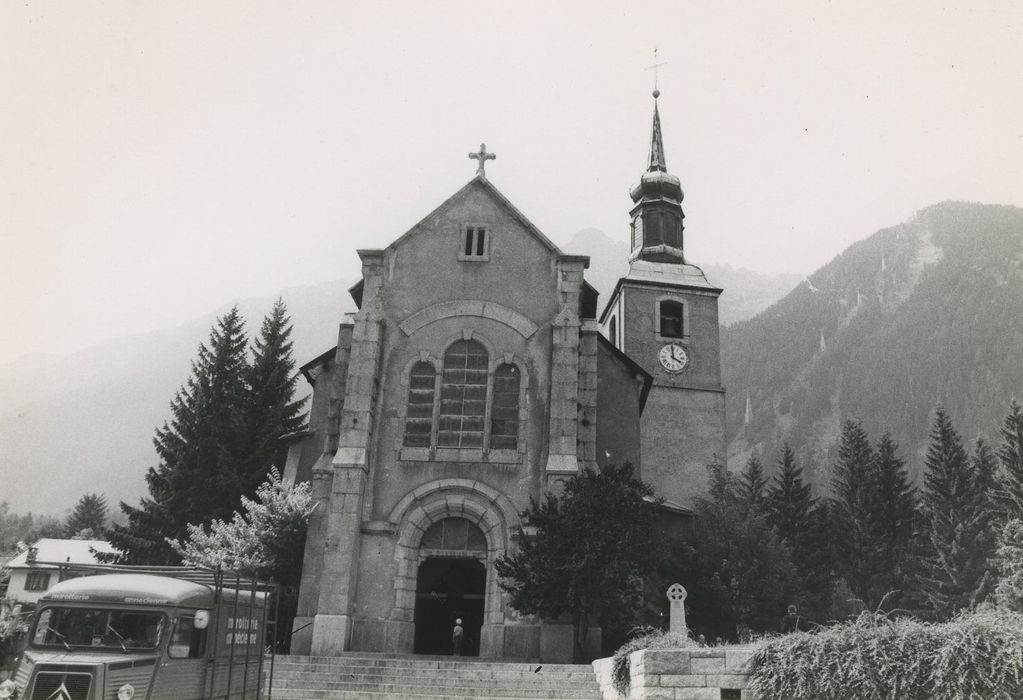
404,340,522,449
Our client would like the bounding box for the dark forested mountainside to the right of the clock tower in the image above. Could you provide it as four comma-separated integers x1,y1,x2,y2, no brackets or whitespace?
721,202,1023,483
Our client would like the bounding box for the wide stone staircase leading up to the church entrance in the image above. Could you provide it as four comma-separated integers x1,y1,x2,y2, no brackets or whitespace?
270,652,601,700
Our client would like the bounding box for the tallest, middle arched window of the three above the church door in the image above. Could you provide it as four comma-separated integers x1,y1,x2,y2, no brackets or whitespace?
437,341,489,447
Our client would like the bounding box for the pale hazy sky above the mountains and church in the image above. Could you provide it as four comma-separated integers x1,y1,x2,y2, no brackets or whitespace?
0,0,1023,362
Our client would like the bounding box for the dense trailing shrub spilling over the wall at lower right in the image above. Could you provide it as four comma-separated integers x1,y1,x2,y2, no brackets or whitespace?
750,609,1023,700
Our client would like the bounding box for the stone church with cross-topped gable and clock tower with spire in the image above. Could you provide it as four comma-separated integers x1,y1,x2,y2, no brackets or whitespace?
285,92,724,662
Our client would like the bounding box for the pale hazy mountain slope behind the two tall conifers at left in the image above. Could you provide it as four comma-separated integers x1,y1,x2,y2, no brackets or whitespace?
0,280,354,513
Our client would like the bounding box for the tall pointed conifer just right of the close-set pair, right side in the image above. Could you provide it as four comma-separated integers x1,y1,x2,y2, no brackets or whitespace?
918,406,993,618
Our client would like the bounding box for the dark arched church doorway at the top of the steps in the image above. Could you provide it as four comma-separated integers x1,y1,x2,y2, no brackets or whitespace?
414,518,487,656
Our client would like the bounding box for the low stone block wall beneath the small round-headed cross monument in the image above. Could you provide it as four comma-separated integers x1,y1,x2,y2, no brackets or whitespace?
593,647,756,700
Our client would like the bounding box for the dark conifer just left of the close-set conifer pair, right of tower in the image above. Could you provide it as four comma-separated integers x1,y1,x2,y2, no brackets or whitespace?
765,443,832,618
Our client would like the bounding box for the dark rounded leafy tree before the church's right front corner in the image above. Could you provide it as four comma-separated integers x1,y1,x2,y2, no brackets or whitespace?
496,464,659,661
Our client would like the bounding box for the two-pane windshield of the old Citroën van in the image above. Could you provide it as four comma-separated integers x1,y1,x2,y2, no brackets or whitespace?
32,606,166,652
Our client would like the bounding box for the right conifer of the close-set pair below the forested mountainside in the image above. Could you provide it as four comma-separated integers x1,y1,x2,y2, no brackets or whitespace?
870,432,917,607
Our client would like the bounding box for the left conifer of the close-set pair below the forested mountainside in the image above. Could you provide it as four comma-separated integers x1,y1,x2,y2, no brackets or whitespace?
829,421,874,606
